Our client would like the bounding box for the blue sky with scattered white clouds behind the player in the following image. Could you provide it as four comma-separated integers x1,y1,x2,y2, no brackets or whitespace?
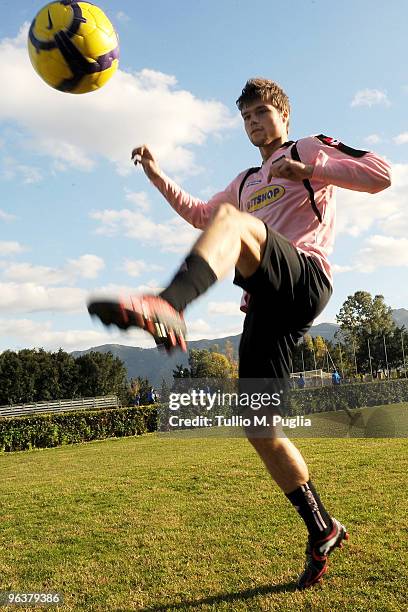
0,0,408,351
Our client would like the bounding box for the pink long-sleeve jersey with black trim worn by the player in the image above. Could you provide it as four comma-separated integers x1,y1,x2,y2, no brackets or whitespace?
148,135,391,296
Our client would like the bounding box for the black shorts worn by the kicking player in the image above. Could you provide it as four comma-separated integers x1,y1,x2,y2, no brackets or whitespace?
234,226,333,379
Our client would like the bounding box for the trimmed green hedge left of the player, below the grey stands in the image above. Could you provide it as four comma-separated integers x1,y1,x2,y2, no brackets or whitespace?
0,406,157,452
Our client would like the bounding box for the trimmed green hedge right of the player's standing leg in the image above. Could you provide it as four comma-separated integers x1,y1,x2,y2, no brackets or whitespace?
289,379,408,414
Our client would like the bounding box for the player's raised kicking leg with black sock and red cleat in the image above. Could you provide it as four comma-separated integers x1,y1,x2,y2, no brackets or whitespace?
88,204,267,350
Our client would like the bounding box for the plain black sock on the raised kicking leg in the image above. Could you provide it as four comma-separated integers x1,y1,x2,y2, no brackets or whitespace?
160,253,217,312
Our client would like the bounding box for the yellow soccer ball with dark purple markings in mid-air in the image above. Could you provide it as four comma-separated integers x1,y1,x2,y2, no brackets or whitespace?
28,0,119,94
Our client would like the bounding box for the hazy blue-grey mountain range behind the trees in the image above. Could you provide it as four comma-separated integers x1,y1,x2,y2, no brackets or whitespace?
72,308,408,387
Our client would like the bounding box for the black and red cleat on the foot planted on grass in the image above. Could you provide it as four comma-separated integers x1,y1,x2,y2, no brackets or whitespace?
297,518,349,589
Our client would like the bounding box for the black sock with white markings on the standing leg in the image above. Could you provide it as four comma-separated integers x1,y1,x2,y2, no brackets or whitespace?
286,480,333,540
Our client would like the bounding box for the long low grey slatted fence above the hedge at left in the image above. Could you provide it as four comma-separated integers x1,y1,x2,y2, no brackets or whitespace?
0,395,120,417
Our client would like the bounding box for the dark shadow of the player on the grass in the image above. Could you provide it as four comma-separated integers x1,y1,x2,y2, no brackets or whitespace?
141,582,296,612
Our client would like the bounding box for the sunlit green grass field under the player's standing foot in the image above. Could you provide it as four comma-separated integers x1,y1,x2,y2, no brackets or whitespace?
0,404,408,612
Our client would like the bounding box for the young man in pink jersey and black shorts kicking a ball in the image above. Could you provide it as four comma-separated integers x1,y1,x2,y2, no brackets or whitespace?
88,79,390,588
